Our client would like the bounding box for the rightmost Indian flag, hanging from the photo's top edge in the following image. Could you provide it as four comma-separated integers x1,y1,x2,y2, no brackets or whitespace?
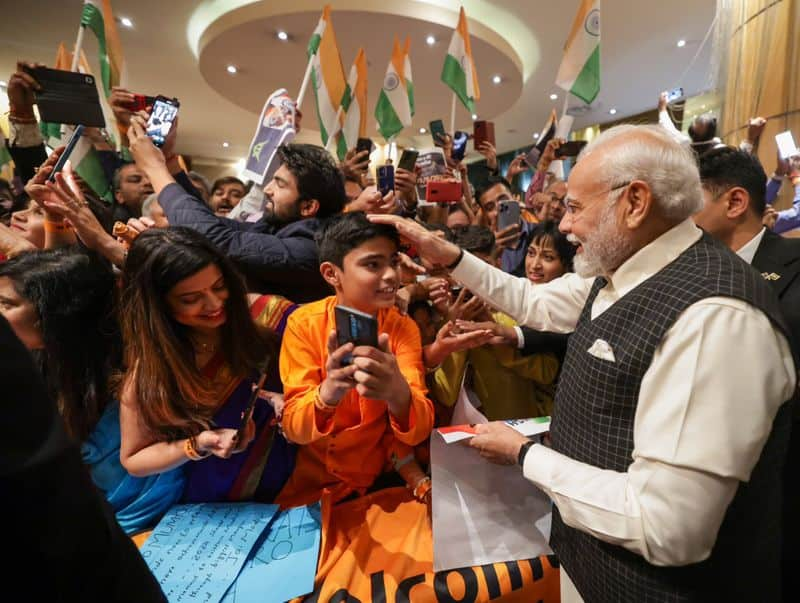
556,0,600,103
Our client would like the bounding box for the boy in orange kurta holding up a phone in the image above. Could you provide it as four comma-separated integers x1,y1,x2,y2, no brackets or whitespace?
276,212,434,506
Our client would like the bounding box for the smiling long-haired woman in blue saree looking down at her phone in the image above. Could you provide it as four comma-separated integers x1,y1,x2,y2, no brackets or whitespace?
120,228,294,502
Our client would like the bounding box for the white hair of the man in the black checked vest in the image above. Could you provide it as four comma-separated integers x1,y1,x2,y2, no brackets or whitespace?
579,124,703,221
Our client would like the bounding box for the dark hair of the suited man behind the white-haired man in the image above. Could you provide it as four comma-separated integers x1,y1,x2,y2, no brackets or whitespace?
698,147,767,217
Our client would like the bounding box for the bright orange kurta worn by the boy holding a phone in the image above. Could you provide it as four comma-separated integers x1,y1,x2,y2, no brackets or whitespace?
276,296,434,507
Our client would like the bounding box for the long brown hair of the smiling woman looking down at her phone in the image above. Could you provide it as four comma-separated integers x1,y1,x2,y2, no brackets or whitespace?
120,227,276,440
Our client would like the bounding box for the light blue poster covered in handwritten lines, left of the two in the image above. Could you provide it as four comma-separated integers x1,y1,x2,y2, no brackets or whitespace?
141,503,278,603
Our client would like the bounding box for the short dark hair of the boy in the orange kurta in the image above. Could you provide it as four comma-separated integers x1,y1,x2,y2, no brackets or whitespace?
315,211,400,268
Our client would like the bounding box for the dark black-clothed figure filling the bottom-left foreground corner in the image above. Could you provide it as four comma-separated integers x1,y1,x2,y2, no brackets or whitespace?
0,317,166,603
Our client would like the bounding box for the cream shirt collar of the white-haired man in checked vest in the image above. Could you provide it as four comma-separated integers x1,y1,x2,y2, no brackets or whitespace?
609,218,703,297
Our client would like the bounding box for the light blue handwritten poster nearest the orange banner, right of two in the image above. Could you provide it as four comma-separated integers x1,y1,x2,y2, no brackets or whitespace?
222,503,322,603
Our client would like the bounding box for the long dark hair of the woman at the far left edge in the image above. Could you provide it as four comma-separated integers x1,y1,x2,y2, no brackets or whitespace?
0,248,122,441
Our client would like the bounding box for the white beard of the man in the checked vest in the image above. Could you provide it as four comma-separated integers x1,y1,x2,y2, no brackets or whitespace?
567,202,633,278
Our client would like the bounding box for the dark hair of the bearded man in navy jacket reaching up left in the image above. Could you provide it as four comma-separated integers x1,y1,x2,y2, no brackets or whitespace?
278,144,347,218
